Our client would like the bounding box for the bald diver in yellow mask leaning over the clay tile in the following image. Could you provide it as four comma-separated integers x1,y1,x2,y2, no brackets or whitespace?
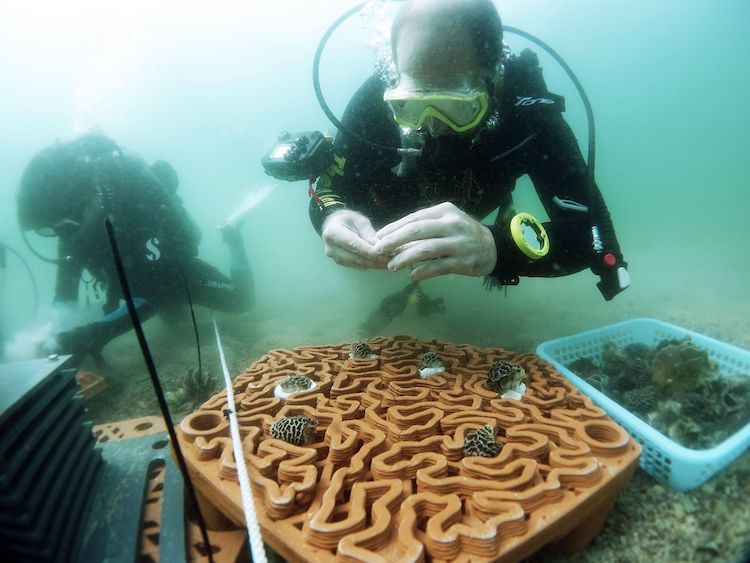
309,0,629,312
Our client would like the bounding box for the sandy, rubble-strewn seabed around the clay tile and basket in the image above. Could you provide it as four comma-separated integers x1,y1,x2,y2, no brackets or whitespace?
86,286,750,563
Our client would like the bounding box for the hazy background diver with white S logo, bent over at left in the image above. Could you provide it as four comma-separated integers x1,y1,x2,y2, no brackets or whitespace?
17,133,254,361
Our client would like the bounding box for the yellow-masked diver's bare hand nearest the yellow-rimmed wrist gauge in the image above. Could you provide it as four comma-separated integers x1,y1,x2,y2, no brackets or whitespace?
376,202,497,281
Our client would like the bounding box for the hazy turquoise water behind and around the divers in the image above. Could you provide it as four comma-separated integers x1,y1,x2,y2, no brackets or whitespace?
0,0,750,408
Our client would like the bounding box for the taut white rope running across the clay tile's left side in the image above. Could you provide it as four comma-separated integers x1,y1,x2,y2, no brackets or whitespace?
213,319,267,563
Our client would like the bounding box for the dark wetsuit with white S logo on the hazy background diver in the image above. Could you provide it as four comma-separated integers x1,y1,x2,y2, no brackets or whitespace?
55,155,254,353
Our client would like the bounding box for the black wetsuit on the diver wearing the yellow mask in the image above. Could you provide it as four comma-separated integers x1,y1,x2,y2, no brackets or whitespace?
310,49,623,285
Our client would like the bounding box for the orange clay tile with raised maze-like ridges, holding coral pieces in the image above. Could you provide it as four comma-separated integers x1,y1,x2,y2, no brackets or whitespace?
179,336,640,562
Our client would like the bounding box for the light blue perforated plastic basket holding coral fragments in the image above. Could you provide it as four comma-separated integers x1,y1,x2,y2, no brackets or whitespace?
537,319,750,491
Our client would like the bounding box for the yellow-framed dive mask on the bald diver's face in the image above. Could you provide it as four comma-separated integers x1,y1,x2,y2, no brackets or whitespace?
383,78,490,134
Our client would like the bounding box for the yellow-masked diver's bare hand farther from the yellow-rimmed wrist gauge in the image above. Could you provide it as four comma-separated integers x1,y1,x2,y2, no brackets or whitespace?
322,209,388,269
